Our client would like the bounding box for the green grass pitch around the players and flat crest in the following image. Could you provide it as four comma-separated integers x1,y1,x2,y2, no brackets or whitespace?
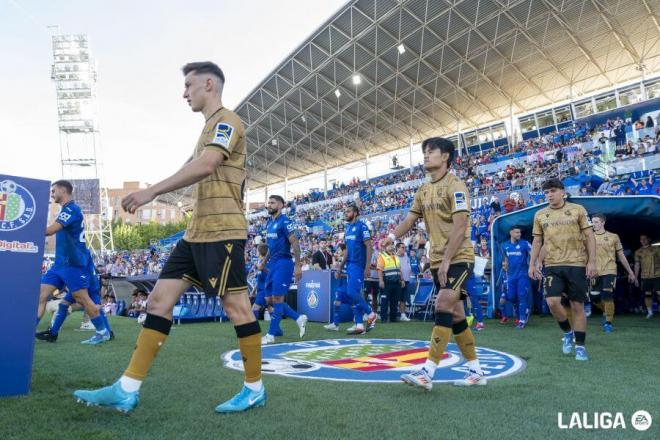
0,314,660,440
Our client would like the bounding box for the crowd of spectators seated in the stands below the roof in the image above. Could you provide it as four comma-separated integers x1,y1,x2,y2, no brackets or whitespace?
44,112,660,288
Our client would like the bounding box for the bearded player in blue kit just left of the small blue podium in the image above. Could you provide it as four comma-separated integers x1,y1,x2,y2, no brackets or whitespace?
258,195,307,345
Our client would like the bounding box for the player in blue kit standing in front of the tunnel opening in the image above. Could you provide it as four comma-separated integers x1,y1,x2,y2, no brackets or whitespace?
502,226,532,329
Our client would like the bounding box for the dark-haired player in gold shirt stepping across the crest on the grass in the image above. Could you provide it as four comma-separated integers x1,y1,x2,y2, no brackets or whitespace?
390,137,486,390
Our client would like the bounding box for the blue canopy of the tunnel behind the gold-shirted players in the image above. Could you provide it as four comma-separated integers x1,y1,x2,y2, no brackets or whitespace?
489,196,660,312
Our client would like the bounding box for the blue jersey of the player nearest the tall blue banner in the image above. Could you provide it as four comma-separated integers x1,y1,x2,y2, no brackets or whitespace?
55,200,91,267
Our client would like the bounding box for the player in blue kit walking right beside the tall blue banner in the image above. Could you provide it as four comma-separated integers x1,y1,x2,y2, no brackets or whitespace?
37,180,110,345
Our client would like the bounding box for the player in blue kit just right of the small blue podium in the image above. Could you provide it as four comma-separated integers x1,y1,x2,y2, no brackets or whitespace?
339,204,376,335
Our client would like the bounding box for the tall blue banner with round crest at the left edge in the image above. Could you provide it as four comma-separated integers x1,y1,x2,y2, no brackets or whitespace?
0,174,50,396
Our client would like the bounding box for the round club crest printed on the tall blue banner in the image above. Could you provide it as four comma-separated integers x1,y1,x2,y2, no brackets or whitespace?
0,180,35,231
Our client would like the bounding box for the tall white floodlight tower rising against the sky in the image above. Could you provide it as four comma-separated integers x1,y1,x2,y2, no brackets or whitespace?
51,34,114,253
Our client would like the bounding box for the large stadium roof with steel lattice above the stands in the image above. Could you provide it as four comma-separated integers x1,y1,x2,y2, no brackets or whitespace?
236,0,660,189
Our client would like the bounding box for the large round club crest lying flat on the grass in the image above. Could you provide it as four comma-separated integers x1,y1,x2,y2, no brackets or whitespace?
222,339,525,382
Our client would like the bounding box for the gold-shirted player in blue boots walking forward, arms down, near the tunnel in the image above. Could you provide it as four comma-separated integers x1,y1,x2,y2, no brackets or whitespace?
529,179,597,361
